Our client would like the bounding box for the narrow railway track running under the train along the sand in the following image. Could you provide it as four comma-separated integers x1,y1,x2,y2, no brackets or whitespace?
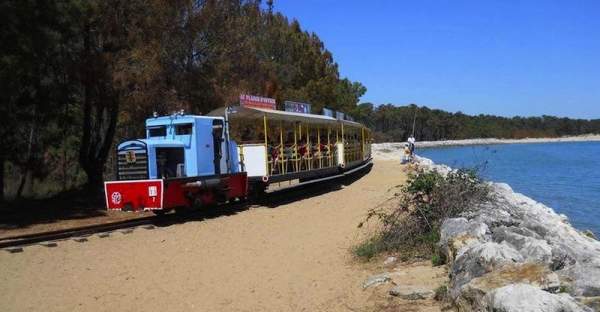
0,162,366,253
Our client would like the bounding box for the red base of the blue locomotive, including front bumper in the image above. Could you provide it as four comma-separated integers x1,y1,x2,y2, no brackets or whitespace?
104,172,248,211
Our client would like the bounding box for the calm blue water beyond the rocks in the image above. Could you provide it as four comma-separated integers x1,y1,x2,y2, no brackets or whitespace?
417,142,600,235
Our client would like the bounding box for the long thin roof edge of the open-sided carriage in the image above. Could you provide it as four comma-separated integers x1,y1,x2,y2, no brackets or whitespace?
206,106,364,127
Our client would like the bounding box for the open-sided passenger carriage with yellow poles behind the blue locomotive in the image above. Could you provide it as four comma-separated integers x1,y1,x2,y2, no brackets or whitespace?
209,106,371,189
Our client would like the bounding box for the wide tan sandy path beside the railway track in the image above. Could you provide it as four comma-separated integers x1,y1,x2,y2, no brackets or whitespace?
0,161,424,311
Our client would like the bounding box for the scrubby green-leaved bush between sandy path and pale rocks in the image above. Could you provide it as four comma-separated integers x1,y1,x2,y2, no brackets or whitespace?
354,169,492,265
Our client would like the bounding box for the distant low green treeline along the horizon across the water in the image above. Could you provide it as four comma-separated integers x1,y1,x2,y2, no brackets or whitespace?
352,103,600,142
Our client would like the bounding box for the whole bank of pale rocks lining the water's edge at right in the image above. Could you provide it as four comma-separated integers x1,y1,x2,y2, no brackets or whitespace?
414,155,600,312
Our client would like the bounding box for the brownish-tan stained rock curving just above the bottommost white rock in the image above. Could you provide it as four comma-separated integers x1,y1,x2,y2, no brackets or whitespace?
456,263,560,311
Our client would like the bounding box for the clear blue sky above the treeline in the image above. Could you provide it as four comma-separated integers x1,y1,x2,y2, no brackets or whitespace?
274,0,600,118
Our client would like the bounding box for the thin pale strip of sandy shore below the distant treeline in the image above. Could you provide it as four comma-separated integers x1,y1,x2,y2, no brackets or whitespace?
377,134,600,148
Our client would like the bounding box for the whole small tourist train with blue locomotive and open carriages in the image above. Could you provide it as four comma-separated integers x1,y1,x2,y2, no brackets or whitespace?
104,95,371,214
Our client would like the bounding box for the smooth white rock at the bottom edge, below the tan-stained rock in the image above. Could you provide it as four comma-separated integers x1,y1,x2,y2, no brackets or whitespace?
477,284,591,312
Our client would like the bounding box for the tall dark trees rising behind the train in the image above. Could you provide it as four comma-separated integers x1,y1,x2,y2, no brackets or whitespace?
0,0,366,200
